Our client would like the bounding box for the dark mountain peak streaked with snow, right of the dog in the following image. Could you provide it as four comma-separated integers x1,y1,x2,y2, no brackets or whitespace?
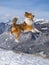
34,19,49,32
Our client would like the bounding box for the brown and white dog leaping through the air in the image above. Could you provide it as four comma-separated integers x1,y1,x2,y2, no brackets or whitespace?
11,12,40,42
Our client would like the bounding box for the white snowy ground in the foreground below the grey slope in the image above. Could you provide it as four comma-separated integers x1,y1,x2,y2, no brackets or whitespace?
0,49,49,65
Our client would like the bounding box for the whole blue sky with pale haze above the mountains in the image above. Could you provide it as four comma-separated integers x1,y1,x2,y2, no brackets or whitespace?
0,0,49,22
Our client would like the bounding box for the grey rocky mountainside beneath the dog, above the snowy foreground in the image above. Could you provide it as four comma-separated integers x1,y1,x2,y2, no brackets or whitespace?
0,32,49,56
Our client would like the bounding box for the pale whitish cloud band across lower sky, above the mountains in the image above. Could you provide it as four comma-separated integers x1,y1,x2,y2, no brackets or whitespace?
0,6,49,22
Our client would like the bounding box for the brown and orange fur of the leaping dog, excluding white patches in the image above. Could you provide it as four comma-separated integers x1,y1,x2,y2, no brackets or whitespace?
11,12,34,39
